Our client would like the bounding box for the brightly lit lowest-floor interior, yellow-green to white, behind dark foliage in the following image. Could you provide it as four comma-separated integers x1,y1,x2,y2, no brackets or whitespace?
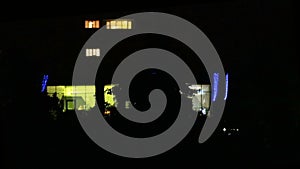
47,84,211,115
